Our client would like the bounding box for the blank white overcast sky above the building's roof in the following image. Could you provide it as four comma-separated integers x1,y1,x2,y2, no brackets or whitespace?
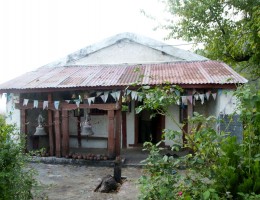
0,0,191,112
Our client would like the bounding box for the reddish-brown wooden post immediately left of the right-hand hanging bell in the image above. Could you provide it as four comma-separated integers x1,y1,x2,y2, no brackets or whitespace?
62,110,69,157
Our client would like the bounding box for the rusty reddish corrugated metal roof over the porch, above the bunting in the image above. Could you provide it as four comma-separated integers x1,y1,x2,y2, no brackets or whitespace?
0,61,247,91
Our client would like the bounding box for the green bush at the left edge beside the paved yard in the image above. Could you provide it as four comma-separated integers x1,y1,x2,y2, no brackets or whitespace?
0,116,36,200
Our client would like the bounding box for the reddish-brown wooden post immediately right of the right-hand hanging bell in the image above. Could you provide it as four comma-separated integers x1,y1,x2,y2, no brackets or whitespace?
108,110,115,158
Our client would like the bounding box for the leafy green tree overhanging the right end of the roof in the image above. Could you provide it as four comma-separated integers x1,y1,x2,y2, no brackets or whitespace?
161,0,260,80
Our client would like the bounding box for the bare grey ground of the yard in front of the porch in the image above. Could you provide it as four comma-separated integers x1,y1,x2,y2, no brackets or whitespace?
31,163,142,200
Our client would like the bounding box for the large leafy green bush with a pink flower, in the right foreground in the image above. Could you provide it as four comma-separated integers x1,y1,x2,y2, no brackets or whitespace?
139,87,260,200
